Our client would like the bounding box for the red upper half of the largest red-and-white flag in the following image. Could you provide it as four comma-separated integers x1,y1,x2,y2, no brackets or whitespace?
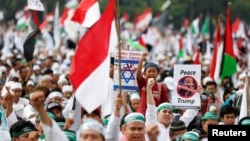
70,0,114,89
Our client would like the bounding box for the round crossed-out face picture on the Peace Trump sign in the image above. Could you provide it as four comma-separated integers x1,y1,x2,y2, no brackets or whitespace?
177,76,198,98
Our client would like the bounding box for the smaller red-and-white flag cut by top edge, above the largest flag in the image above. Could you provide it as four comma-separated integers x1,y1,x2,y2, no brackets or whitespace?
71,0,100,28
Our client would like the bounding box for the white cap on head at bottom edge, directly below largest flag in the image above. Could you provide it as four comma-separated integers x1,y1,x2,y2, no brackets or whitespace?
77,119,106,139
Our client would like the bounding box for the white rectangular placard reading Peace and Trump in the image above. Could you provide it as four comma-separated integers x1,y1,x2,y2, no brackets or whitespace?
171,64,201,109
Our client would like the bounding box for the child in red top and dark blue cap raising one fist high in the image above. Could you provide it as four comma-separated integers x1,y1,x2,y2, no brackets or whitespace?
136,53,169,114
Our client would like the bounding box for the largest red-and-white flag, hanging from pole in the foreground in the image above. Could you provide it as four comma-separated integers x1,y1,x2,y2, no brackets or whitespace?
70,0,117,113
